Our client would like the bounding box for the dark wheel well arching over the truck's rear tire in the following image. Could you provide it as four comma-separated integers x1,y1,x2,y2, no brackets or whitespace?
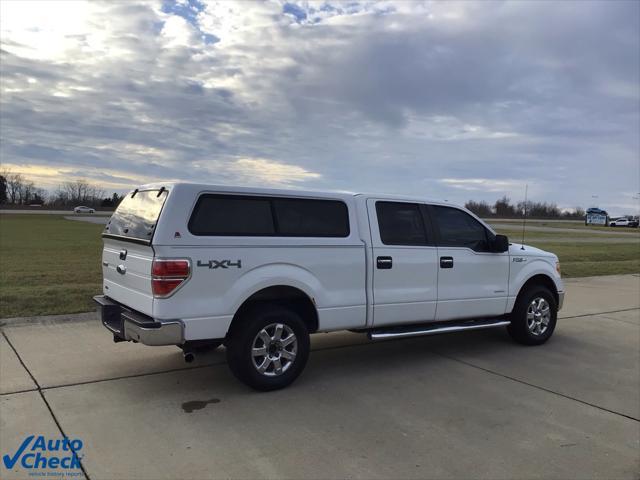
229,285,318,333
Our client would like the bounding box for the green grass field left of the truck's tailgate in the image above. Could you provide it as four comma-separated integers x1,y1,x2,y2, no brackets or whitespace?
0,214,104,318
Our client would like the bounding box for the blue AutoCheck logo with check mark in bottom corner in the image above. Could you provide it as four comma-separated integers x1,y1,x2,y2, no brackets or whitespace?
2,435,83,477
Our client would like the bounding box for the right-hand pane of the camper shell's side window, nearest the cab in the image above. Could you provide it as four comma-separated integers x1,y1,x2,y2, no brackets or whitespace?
273,199,349,237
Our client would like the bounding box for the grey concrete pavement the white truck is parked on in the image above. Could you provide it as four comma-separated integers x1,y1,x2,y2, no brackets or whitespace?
0,275,640,479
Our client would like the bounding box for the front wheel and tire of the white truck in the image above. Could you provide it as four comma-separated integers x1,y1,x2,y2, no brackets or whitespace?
507,286,558,345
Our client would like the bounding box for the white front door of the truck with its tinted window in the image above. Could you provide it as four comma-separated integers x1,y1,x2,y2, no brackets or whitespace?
429,205,509,321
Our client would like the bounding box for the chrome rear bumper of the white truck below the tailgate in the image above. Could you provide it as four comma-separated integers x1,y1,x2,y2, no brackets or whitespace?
93,295,184,345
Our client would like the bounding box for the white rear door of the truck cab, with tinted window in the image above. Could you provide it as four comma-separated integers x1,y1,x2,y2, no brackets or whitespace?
367,199,438,327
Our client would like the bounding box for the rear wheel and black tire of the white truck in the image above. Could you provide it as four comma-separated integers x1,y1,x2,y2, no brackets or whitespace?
226,304,309,391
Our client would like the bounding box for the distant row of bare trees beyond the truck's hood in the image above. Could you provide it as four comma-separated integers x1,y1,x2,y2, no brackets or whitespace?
464,196,585,219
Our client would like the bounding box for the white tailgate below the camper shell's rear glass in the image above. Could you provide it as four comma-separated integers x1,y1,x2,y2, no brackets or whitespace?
102,238,153,316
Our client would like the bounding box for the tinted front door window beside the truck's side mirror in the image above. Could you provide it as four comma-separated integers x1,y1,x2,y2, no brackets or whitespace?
432,206,487,250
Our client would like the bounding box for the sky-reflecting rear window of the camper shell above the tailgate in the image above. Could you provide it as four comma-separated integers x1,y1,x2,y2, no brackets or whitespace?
103,188,167,243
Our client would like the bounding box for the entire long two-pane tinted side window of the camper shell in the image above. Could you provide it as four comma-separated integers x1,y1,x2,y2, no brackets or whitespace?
189,195,349,237
